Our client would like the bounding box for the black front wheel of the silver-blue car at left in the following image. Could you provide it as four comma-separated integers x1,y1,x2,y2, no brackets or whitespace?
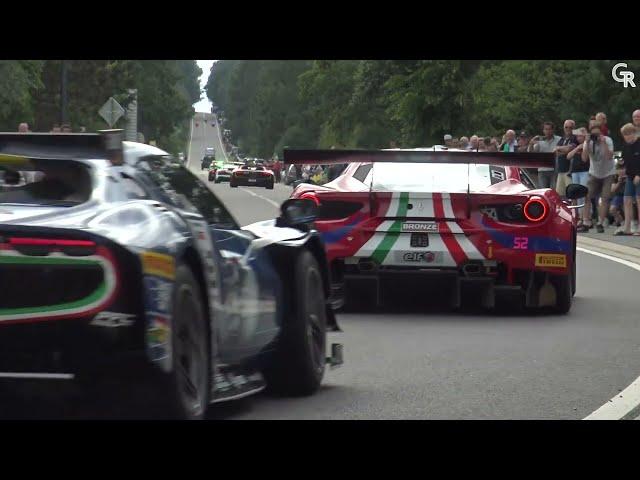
263,250,327,395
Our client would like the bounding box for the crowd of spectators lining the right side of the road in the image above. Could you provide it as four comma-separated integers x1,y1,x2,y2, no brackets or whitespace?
444,109,640,236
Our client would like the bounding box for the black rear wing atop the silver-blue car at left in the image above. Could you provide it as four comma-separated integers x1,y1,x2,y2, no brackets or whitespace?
0,130,123,165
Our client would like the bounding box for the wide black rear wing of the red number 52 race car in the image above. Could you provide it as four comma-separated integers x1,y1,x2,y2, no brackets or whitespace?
284,149,555,168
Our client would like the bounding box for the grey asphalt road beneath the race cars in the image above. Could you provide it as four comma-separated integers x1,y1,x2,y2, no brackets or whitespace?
3,113,640,419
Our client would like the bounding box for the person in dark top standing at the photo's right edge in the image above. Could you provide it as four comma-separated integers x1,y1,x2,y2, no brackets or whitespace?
616,123,640,236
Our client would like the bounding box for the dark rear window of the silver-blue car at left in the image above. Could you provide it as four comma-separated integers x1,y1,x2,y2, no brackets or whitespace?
0,157,93,207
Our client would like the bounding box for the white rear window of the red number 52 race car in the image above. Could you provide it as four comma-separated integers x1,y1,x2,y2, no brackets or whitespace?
371,163,491,193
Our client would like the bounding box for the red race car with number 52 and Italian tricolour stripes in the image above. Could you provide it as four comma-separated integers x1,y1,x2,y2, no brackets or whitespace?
284,148,586,313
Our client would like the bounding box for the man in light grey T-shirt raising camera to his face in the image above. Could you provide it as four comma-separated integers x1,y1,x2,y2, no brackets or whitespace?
578,121,616,233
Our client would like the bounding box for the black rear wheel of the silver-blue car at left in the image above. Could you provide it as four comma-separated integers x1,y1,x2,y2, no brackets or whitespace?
158,265,212,420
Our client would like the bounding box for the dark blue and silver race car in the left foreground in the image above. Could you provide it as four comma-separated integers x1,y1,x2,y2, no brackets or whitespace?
0,131,341,419
